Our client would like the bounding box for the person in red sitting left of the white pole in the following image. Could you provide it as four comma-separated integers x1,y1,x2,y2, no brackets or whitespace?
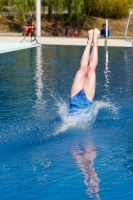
22,19,35,36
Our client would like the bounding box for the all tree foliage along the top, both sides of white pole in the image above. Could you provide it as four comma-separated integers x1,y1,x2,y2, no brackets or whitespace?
0,0,133,22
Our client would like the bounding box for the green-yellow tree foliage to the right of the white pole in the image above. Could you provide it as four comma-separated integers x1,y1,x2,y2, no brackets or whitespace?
42,0,133,21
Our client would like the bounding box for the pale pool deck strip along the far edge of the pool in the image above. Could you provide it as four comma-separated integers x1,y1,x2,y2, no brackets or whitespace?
0,35,132,47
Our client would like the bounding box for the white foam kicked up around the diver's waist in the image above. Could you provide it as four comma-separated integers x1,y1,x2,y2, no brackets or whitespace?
53,98,118,136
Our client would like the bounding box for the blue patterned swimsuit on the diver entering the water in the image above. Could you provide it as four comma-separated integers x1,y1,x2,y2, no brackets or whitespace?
69,90,92,115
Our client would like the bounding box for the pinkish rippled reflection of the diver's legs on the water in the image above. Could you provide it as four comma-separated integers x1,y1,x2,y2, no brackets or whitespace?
72,145,100,200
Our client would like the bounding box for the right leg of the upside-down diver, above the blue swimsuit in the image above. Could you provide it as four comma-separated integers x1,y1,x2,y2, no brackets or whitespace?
84,28,100,102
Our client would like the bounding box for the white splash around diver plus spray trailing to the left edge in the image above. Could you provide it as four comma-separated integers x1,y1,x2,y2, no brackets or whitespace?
0,87,119,152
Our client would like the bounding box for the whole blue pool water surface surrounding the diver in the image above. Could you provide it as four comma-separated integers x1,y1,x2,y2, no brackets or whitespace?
0,45,133,200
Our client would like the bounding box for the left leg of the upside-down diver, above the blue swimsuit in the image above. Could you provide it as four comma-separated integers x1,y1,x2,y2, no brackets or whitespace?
71,30,93,97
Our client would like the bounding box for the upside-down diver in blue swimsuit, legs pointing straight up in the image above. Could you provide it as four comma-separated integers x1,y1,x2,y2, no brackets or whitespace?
69,28,100,115
